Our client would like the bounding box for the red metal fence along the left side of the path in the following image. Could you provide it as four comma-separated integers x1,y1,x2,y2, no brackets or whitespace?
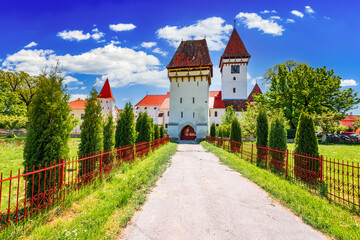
0,137,169,232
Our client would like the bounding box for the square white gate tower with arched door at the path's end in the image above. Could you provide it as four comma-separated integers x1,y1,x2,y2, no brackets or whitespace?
166,39,213,140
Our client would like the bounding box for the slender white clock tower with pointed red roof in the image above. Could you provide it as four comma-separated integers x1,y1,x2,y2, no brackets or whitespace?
219,28,251,100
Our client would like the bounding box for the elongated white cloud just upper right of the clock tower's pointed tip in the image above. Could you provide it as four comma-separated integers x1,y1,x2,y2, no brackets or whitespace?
236,12,285,36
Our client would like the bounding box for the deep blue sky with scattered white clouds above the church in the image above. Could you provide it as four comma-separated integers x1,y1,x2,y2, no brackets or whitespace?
0,0,360,114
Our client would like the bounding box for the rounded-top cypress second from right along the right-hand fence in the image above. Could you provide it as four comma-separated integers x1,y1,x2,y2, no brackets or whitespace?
268,115,287,170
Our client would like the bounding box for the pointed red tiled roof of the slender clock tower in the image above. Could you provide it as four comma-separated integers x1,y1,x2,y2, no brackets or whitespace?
219,28,251,66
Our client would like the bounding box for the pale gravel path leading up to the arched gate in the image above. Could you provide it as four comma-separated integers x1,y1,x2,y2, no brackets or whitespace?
122,144,327,240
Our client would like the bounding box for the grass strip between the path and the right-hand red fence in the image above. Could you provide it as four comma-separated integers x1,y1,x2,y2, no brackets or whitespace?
201,142,360,239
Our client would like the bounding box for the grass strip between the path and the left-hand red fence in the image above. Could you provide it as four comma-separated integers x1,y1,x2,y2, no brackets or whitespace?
0,143,176,239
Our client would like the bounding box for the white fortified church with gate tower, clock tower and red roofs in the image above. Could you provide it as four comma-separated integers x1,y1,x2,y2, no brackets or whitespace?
134,28,262,140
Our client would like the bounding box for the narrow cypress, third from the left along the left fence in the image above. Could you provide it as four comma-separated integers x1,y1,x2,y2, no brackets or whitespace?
103,114,115,166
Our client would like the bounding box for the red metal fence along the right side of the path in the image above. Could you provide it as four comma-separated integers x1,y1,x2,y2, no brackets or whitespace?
206,137,360,210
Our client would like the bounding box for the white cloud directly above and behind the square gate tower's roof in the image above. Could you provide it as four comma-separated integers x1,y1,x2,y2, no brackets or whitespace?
156,17,233,51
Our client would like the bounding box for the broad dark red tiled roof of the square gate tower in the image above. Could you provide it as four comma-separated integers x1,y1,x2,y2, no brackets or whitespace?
166,39,212,75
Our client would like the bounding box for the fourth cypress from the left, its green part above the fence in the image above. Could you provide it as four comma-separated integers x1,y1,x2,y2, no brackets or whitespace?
115,102,137,147
